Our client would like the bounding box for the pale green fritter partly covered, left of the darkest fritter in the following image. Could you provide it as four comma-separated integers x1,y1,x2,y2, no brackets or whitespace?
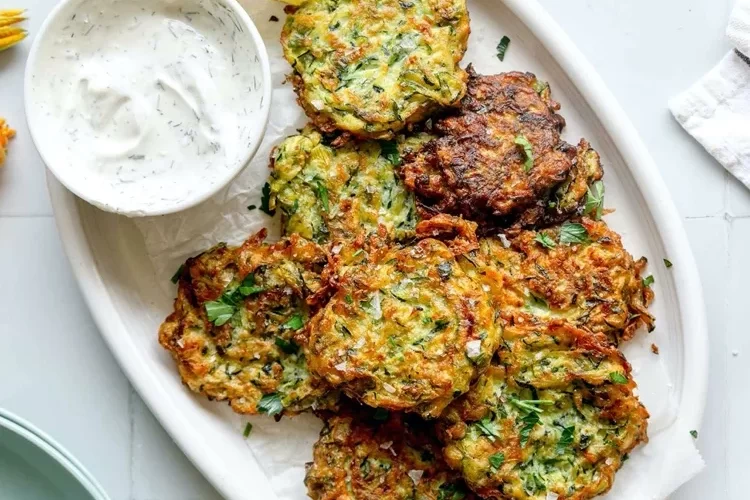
269,127,434,243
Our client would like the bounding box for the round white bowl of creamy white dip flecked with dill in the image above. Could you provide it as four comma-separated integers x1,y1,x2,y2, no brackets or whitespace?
24,0,272,217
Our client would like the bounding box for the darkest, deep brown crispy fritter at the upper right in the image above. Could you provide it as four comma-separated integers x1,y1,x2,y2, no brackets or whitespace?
401,67,602,227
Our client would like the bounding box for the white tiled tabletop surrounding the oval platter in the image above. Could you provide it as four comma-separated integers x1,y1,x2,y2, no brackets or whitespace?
0,0,750,500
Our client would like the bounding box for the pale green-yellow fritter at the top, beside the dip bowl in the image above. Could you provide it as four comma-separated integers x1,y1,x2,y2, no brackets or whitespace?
281,0,469,139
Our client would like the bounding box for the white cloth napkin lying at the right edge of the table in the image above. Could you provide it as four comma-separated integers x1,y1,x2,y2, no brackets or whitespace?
669,0,750,188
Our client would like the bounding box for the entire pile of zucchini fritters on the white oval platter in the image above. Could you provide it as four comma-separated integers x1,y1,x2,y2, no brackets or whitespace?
159,0,654,500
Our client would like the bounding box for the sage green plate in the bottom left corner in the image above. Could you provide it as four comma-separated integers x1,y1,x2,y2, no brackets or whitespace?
0,409,109,500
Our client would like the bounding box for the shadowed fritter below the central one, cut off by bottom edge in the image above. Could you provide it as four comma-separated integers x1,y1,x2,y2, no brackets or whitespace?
305,405,475,500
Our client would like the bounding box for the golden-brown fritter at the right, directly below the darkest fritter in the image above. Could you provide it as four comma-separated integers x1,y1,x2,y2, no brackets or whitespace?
460,217,654,344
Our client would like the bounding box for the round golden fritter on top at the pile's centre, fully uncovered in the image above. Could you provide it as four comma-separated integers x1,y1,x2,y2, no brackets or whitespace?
306,239,500,418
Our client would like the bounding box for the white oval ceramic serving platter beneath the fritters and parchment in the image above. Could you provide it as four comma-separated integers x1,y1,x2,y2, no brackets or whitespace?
48,0,708,500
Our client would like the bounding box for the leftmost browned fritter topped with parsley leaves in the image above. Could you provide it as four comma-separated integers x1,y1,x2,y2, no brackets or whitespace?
159,230,336,415
